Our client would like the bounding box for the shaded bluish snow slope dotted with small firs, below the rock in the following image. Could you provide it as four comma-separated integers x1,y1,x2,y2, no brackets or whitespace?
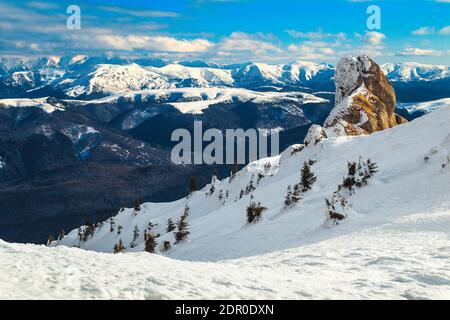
55,107,450,261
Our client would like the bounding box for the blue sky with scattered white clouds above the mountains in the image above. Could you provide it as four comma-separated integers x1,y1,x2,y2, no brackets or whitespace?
0,0,450,65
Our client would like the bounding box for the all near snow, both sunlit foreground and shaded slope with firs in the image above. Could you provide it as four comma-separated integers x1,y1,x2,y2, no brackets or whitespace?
0,106,450,299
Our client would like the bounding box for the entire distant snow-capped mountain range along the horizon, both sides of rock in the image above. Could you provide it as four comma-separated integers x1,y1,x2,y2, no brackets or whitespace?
0,55,450,98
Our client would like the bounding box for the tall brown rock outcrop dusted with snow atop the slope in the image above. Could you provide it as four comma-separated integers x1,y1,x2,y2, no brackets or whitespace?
310,56,407,142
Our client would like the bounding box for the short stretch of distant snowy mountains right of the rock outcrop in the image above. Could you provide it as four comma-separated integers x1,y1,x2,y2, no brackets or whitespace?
381,62,450,81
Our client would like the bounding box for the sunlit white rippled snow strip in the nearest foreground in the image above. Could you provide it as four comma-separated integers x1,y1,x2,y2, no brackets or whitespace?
0,219,450,299
